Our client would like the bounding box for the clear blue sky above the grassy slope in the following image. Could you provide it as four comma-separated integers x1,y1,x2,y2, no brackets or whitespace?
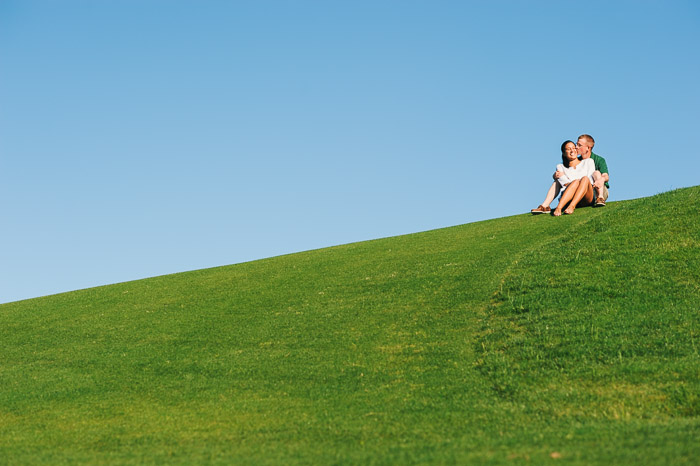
0,0,700,302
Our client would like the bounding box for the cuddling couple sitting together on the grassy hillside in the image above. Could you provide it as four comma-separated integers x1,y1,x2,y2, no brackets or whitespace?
530,134,610,217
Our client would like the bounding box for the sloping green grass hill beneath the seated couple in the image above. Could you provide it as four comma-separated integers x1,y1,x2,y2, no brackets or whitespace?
0,187,700,465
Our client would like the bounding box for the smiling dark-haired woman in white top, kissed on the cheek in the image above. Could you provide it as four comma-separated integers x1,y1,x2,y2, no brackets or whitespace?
530,141,595,217
